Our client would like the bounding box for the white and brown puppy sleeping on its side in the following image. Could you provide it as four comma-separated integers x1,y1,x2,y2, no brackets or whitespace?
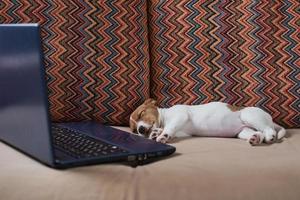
130,99,286,145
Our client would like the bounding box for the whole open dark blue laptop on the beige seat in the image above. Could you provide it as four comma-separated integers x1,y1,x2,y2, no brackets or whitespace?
0,24,175,168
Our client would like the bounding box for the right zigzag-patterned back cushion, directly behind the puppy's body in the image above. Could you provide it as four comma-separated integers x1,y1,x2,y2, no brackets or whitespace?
148,0,300,128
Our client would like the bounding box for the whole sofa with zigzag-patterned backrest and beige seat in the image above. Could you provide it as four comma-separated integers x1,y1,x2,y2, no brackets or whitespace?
0,0,300,200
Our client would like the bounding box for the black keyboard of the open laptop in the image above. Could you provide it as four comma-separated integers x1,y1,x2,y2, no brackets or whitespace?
52,126,128,158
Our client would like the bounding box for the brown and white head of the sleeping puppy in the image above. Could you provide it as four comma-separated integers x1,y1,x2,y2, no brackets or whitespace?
129,99,159,137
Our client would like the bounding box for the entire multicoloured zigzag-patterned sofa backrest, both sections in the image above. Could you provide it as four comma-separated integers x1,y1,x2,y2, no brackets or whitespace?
0,0,300,127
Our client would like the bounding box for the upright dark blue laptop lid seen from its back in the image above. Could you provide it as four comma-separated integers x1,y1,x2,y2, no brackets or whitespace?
0,24,53,165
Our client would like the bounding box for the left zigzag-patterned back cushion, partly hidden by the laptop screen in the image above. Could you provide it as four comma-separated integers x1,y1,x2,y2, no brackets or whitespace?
0,0,150,125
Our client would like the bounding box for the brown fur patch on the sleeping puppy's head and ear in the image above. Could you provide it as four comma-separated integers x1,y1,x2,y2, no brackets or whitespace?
129,98,159,132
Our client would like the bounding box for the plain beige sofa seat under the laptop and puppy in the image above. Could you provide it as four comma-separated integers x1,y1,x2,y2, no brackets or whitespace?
0,128,300,200
